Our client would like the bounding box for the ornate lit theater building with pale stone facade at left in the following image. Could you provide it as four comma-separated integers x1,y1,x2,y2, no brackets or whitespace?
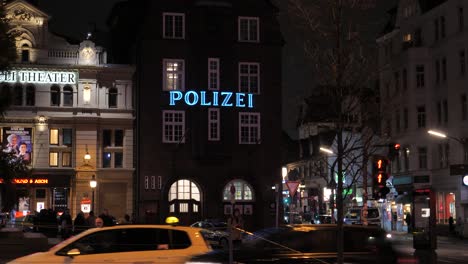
0,0,134,217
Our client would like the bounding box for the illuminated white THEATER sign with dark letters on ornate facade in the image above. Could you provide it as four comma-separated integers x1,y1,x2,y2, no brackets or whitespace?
0,70,78,84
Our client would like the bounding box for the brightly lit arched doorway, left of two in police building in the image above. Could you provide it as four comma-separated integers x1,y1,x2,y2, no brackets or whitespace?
168,180,201,225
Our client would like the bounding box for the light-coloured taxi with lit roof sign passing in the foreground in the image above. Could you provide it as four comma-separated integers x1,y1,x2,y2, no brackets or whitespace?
8,225,212,264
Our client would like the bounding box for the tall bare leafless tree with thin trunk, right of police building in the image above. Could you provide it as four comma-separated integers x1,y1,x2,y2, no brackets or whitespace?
288,0,386,263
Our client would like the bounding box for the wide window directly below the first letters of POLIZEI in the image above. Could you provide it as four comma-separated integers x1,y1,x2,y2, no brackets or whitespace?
162,111,185,143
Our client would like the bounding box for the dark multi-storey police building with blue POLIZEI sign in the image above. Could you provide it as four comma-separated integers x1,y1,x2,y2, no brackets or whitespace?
129,0,283,229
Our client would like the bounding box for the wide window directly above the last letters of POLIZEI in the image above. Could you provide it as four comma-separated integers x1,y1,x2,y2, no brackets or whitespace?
239,62,260,94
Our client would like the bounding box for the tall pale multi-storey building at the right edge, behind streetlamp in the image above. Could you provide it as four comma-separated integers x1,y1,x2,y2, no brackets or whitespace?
377,0,468,223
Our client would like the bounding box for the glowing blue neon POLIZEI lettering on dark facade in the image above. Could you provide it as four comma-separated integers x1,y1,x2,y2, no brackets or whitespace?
169,91,253,108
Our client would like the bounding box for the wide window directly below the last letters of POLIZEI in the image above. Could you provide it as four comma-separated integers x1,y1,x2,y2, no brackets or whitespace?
239,112,260,144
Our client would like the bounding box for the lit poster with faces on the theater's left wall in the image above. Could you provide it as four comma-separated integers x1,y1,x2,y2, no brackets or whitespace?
2,127,32,164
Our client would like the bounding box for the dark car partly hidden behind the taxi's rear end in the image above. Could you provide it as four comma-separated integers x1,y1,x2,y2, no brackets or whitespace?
190,220,229,248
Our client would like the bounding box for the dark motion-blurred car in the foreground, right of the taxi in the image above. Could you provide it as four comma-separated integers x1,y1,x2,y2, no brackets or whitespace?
186,224,412,264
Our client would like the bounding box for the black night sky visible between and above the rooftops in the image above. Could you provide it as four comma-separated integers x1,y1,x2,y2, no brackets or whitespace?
33,0,396,138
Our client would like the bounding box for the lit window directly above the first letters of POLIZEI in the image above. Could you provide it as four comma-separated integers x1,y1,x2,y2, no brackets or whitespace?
163,59,185,91
